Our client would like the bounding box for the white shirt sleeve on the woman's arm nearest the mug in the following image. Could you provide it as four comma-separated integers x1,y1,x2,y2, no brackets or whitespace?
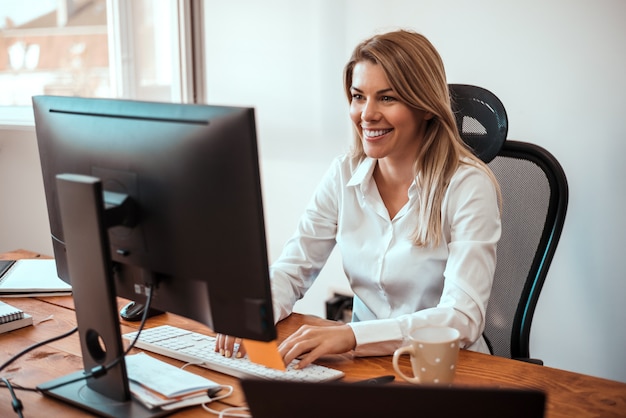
350,166,501,355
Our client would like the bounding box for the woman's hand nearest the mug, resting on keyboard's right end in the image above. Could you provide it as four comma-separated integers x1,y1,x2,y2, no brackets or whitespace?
278,325,356,369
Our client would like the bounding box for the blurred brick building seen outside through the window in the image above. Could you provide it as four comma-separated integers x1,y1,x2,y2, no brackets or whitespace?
0,0,112,106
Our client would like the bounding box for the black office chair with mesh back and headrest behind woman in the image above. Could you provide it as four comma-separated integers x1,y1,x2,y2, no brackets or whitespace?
449,84,568,364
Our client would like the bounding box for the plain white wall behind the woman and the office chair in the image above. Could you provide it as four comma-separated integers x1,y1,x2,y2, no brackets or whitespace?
0,0,626,382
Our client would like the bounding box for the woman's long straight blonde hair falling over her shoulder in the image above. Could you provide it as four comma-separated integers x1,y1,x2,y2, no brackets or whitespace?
344,30,499,246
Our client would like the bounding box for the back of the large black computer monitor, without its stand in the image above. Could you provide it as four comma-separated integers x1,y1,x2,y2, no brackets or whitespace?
33,96,276,341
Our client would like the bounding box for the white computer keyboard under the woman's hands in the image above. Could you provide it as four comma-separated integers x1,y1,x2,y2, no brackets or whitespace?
123,325,344,382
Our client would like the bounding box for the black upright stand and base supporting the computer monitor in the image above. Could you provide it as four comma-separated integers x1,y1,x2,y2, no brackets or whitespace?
38,174,166,418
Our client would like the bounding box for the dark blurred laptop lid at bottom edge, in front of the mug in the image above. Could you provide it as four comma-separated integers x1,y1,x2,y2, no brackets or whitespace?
241,379,546,418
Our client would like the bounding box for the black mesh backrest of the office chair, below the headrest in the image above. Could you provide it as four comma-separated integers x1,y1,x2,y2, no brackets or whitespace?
485,141,568,359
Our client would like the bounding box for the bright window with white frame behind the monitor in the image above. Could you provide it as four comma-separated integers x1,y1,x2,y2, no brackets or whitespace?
0,0,202,119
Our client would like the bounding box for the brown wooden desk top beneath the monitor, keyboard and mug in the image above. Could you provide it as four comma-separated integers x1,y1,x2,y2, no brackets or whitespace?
0,253,626,418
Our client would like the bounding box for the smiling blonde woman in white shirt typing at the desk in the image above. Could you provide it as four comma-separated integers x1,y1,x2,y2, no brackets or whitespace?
216,30,500,367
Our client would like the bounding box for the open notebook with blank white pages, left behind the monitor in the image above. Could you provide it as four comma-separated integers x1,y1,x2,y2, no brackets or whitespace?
0,259,72,297
